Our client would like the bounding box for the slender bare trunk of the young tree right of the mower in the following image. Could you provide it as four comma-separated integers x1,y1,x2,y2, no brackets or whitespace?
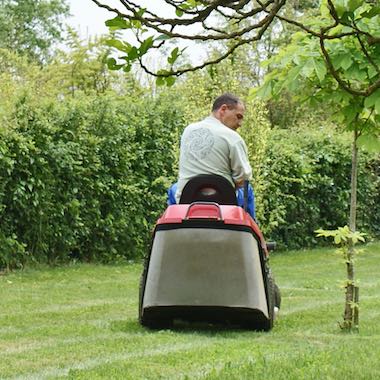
344,129,359,330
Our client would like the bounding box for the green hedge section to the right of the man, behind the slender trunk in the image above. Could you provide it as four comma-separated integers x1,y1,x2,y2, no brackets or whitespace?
257,129,380,248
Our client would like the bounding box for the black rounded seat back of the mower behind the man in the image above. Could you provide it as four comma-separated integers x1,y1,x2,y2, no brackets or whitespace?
179,174,237,206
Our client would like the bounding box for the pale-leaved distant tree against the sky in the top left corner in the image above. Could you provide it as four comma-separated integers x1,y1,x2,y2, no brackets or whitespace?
0,0,69,62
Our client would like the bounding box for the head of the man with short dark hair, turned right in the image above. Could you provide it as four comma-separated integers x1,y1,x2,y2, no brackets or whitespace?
212,93,245,131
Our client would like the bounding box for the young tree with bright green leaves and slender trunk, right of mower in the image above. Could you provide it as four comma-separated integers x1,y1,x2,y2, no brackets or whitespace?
258,0,380,330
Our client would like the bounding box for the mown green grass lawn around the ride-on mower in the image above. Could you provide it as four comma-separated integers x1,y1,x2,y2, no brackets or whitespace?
0,243,380,380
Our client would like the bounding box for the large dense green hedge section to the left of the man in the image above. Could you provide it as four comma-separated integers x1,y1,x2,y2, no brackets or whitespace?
0,96,181,267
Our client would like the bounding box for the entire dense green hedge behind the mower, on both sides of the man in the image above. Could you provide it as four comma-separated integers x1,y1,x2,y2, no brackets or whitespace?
0,94,380,268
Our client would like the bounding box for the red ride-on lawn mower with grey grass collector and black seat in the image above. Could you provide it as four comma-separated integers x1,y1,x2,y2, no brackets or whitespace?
139,175,280,331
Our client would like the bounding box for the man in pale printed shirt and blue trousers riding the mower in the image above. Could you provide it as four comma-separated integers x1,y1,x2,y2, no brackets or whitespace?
169,93,255,217
